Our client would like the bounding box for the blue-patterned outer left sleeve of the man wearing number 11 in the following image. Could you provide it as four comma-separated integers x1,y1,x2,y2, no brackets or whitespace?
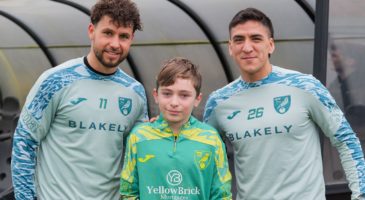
11,68,67,200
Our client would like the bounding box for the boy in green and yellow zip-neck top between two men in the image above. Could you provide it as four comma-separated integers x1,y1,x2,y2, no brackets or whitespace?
120,58,231,200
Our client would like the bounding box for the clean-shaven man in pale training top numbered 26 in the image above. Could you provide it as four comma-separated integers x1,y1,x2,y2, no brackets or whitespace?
204,8,365,200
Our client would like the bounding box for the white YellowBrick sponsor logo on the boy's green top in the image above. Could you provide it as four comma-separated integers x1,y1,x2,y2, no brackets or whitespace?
147,169,200,200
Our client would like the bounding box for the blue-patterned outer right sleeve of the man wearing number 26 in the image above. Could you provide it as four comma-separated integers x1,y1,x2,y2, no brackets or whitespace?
307,76,365,199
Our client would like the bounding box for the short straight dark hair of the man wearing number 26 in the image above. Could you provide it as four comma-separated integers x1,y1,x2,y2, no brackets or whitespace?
229,8,274,38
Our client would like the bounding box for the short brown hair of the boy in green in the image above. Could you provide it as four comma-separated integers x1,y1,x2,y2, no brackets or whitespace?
156,57,202,95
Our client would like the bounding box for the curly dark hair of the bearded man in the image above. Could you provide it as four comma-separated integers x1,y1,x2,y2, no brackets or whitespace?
90,0,142,32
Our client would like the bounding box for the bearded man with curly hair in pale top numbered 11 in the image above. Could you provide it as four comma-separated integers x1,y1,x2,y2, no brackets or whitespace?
12,0,147,200
